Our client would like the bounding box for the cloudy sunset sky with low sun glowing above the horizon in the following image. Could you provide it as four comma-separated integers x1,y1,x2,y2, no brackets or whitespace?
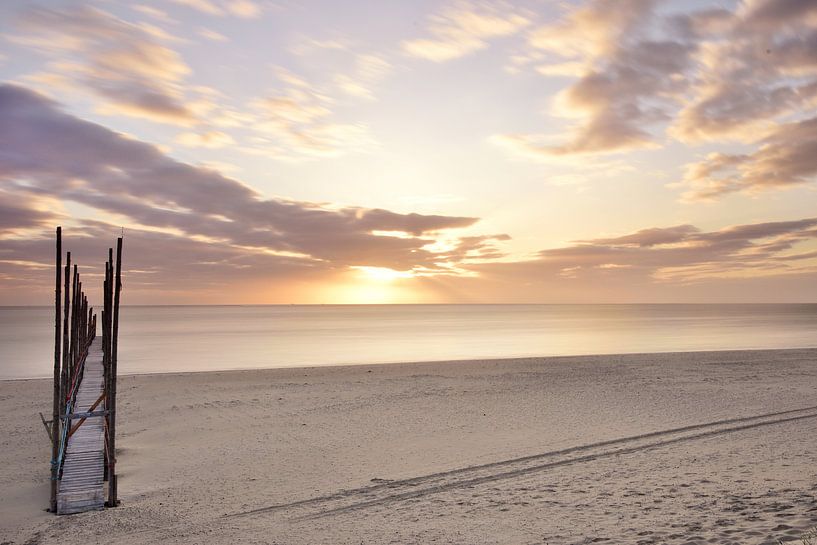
0,0,817,305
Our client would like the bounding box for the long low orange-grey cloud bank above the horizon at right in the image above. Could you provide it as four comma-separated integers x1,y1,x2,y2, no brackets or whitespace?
459,218,817,303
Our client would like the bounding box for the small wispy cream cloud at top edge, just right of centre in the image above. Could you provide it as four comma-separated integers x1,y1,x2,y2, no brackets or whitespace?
402,2,530,62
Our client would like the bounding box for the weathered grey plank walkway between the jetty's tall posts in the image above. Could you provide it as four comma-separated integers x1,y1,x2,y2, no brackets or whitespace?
57,337,105,515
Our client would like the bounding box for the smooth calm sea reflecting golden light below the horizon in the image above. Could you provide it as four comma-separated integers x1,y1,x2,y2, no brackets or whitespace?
0,304,817,379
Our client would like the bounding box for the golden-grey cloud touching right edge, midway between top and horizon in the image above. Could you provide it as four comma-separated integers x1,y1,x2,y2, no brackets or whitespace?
679,117,817,201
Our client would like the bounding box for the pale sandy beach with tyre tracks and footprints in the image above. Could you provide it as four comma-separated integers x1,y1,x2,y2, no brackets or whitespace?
0,349,817,545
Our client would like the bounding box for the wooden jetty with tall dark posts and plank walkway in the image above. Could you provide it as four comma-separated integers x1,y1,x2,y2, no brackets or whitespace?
41,227,122,515
